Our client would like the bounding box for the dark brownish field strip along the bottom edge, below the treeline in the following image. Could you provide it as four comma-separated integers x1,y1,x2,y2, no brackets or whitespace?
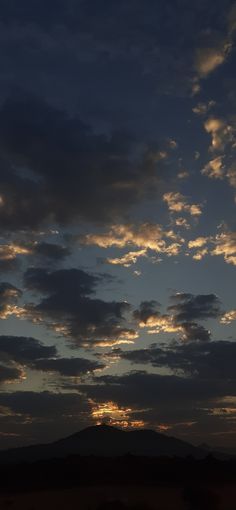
0,484,236,510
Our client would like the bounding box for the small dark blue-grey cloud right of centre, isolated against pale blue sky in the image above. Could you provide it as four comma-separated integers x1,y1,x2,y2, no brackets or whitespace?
168,293,222,323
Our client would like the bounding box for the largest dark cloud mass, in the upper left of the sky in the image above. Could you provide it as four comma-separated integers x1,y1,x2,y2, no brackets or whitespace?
0,96,166,230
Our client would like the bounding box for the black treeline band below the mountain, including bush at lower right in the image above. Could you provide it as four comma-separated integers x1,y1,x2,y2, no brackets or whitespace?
0,455,236,494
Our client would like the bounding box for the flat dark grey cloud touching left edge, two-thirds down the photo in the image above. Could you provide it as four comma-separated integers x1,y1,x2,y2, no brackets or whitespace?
0,335,57,364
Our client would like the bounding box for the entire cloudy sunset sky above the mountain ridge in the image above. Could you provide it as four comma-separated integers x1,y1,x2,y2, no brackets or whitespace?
0,0,236,448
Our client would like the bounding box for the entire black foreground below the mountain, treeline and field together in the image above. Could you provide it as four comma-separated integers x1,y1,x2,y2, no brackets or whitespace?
0,455,236,510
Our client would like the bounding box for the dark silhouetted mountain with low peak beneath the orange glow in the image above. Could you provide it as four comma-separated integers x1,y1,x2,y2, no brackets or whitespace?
0,425,212,464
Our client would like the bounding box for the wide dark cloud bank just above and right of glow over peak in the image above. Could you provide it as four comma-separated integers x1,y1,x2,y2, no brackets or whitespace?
80,371,236,426
